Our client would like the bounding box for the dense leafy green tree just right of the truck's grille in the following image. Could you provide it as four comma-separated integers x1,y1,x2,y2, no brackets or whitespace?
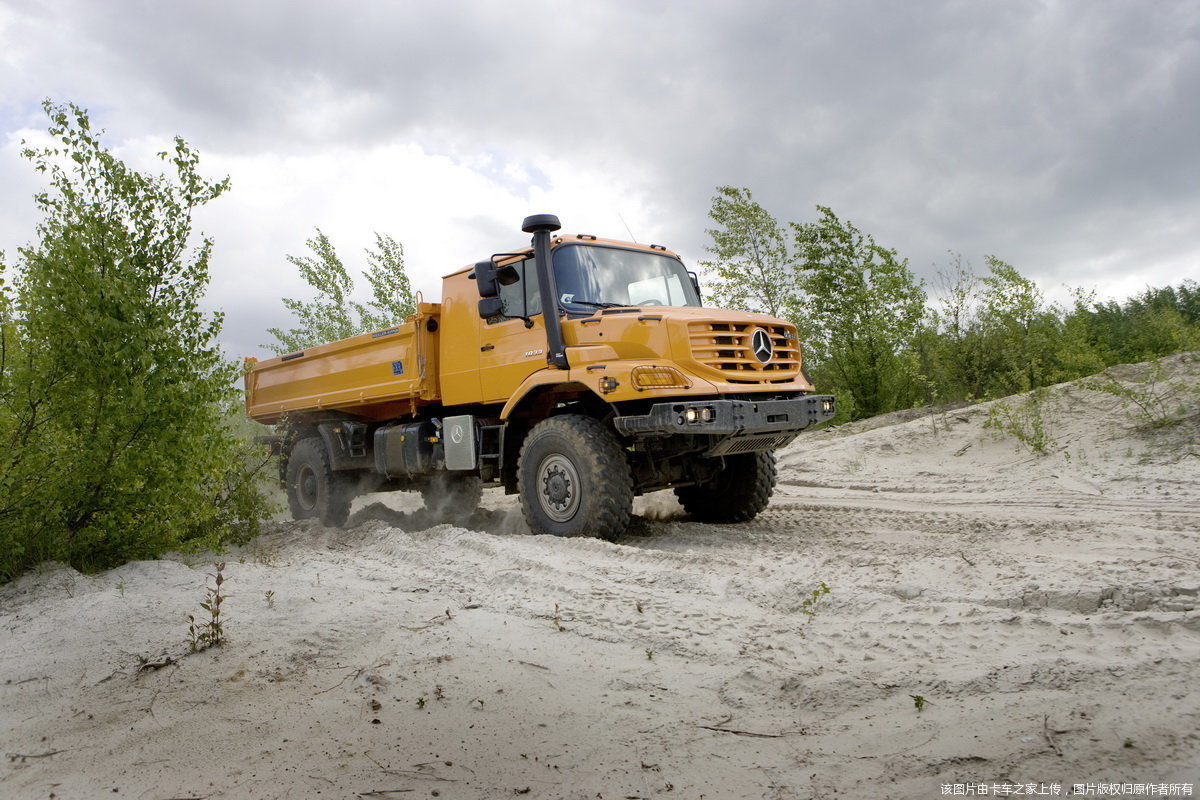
790,205,925,419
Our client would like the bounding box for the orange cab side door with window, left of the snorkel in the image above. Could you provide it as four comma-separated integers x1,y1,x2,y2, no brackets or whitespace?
479,258,546,403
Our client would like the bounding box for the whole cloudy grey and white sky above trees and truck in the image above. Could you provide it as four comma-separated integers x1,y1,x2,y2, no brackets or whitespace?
0,0,1200,356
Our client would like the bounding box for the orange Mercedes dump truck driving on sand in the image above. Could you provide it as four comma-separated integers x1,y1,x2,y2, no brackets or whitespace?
246,215,834,539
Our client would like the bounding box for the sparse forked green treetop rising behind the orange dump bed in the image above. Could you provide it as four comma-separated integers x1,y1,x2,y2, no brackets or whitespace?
268,228,415,353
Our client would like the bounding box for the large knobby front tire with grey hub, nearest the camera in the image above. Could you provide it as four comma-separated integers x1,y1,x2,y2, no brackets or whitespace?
518,414,634,540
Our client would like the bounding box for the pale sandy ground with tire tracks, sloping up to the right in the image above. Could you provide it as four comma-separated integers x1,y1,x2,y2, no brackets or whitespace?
0,356,1200,799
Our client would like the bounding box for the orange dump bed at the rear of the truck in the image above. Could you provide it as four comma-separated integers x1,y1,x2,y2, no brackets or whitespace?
246,302,440,423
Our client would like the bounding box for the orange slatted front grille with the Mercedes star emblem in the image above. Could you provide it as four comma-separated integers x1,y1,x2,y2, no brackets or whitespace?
688,321,800,384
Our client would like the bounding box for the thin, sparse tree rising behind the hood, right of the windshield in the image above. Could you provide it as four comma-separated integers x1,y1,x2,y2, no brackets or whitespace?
701,186,796,317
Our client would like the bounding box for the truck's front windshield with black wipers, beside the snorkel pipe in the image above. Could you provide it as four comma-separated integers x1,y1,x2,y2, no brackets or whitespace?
554,245,700,312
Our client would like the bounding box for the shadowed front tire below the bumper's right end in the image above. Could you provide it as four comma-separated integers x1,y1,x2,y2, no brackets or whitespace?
674,450,775,523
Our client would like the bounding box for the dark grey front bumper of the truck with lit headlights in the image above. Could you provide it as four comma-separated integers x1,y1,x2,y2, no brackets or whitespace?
613,395,836,456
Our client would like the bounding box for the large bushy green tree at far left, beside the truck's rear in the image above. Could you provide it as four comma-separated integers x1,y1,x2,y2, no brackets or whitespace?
0,102,264,579
